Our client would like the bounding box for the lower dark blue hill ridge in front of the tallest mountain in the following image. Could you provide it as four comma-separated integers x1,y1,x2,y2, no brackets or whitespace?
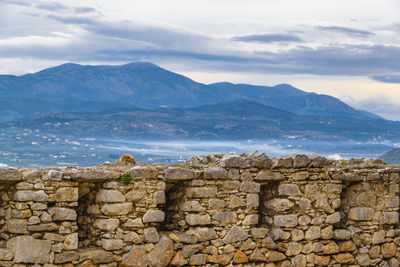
0,99,400,141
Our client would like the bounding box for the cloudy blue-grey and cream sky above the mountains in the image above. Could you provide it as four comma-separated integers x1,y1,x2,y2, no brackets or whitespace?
0,0,400,120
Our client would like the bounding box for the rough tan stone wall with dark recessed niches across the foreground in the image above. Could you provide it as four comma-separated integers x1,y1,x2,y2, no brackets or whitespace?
0,152,400,267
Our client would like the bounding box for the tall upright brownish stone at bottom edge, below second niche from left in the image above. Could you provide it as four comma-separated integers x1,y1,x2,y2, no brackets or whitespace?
147,236,174,267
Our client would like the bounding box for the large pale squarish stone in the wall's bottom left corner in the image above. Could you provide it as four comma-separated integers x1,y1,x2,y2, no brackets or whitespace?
7,236,51,264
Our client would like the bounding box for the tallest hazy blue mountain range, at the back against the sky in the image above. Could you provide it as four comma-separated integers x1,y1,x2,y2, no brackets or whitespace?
0,62,381,121
